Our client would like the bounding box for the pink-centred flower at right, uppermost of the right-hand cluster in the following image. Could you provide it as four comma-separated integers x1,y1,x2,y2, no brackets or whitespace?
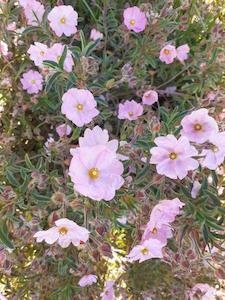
181,108,218,144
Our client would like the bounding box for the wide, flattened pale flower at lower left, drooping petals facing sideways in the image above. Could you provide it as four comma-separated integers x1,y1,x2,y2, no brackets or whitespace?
34,218,89,248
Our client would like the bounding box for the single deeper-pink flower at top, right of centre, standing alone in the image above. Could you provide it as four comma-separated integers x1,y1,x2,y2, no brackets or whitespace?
123,6,147,32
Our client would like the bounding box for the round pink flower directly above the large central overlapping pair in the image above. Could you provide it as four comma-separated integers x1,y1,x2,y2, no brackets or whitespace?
61,88,99,127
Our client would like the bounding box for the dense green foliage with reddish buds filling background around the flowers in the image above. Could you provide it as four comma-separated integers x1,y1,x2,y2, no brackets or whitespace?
0,0,225,300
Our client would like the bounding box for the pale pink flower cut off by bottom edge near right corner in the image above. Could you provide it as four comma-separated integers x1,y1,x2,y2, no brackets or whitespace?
189,283,216,300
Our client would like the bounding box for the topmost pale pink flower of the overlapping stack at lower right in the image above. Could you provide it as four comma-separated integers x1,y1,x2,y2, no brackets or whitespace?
144,198,185,235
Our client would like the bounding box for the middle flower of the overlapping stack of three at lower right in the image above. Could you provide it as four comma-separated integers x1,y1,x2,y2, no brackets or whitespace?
142,224,173,245
